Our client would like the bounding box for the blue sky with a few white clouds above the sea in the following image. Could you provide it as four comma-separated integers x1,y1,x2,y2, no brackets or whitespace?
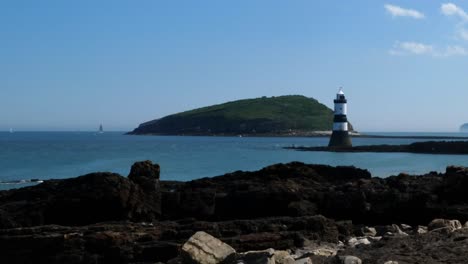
0,0,468,131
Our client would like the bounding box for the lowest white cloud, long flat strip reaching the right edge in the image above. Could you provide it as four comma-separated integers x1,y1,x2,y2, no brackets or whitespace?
389,42,468,57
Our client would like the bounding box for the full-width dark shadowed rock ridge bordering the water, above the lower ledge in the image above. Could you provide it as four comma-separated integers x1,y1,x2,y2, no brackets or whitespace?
4,161,468,227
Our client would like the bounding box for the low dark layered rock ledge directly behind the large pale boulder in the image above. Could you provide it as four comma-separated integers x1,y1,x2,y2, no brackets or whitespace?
0,216,339,264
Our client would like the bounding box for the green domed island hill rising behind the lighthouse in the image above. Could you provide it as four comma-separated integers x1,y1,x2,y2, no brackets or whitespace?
128,95,353,136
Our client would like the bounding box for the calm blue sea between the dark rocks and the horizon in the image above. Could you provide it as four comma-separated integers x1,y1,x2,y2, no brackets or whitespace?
0,132,468,190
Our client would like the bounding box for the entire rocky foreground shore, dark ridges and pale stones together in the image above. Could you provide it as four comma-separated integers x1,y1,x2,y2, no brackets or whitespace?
0,162,468,264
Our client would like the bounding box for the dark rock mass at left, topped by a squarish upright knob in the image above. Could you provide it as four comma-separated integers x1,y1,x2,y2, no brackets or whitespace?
0,162,161,228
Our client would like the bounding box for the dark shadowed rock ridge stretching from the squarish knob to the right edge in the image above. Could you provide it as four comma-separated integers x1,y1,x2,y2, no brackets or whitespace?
162,162,468,225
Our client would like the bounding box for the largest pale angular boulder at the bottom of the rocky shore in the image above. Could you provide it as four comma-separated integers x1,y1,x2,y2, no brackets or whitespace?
182,231,236,264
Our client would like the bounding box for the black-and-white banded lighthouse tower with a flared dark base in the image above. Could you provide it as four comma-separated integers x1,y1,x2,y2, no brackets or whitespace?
328,88,352,148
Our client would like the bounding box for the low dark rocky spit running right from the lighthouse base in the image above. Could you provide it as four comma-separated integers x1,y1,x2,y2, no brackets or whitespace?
285,141,468,155
